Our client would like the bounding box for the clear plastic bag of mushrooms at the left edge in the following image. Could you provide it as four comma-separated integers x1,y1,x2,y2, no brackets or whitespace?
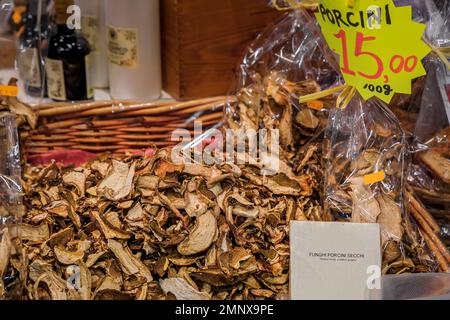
0,112,23,299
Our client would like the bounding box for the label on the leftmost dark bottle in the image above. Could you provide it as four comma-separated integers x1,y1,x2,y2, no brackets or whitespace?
17,48,42,88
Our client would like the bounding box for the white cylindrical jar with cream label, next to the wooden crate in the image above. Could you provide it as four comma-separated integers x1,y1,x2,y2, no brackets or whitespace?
106,0,162,100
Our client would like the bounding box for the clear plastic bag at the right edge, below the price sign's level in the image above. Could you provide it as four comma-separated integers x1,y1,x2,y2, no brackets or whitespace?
408,56,450,241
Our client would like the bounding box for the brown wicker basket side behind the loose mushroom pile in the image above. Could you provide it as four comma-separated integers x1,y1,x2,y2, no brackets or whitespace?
23,97,230,155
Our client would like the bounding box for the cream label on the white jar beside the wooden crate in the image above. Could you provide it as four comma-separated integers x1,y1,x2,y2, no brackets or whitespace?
108,26,138,68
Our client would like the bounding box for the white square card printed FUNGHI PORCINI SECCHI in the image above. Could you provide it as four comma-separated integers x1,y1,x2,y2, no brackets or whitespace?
289,221,381,300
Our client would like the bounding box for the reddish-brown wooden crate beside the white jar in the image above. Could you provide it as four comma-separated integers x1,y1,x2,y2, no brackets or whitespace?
161,0,282,99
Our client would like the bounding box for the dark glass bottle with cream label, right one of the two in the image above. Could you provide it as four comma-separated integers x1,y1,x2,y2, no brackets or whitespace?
45,0,93,101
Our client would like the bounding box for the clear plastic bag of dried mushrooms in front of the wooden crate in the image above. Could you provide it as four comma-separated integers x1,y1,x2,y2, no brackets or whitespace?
226,9,342,160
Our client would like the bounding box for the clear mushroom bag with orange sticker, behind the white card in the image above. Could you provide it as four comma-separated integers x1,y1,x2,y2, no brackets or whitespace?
324,93,436,274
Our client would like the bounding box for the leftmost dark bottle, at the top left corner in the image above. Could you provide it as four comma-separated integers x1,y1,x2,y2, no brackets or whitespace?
17,0,51,97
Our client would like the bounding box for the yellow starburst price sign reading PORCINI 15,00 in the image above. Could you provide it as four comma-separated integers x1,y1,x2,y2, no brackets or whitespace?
316,0,431,103
